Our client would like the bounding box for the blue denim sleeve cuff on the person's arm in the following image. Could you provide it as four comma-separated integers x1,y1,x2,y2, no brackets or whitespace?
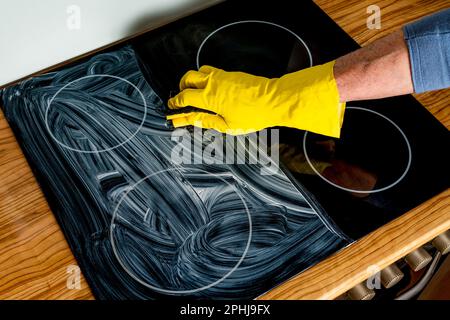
403,8,450,93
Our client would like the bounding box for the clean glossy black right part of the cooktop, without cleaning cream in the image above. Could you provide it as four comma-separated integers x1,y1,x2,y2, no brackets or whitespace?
133,1,450,239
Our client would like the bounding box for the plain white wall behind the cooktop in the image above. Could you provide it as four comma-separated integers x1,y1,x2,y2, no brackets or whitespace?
0,0,217,85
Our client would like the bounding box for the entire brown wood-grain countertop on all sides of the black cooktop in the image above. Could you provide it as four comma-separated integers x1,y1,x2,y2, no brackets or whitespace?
0,0,450,299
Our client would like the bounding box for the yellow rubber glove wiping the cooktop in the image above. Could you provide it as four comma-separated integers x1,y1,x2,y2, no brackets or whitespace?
167,61,345,137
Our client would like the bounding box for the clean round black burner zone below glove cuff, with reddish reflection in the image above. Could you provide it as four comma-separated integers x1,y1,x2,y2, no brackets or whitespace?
303,107,412,197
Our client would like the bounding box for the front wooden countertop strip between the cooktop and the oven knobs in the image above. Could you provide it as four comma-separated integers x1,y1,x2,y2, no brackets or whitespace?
259,190,450,300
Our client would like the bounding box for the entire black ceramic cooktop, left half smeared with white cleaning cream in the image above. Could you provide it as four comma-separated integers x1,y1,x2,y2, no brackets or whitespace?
1,0,450,299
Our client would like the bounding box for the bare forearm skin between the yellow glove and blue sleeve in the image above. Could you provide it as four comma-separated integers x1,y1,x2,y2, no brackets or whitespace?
334,30,414,102
